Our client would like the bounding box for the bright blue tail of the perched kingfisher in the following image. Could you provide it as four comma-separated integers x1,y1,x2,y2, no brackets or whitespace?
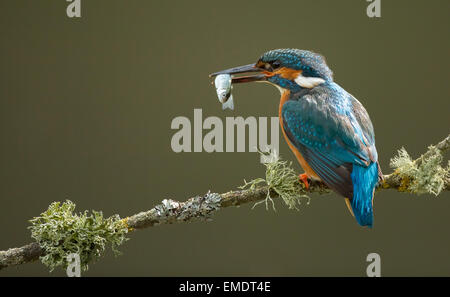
351,163,378,227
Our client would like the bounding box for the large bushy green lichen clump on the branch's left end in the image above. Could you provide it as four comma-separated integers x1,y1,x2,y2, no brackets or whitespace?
28,200,128,271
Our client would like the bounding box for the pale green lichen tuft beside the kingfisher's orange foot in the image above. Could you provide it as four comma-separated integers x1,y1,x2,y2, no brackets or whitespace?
240,152,310,210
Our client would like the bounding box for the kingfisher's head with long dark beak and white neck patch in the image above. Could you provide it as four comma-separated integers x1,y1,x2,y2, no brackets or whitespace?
210,49,333,92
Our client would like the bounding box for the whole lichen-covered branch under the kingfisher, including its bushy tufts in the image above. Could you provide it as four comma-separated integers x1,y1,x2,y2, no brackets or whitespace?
0,135,450,270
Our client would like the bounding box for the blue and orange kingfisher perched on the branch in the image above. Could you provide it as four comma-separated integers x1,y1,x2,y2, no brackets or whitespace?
210,49,383,228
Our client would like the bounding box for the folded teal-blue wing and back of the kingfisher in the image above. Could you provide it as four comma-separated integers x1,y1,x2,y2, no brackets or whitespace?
282,84,378,198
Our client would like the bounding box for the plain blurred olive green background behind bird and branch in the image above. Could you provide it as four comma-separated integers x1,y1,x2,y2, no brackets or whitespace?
0,0,450,276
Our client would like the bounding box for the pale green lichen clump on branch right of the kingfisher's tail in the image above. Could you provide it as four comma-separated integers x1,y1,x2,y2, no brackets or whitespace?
390,146,450,196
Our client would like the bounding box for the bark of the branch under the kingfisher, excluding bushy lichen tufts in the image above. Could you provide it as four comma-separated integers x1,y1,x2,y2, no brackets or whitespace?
0,135,450,270
